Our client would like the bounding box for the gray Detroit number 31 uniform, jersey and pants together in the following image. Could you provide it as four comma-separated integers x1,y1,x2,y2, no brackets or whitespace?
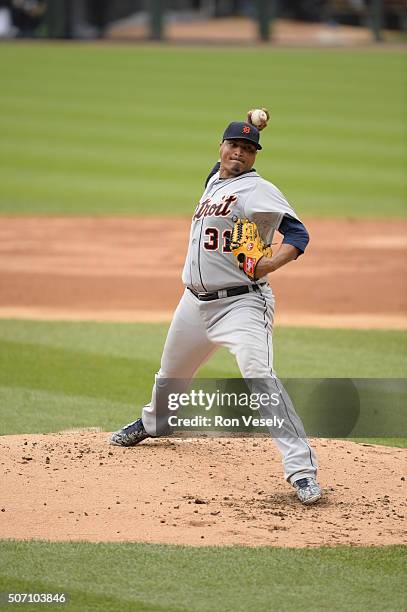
142,171,317,482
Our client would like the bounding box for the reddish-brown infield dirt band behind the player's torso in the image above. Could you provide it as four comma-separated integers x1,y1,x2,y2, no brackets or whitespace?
0,217,407,329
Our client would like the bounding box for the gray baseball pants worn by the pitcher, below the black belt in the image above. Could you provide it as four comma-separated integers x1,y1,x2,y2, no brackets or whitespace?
142,285,317,483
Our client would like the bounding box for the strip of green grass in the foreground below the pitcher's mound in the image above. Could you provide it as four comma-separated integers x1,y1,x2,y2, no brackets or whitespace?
0,541,406,612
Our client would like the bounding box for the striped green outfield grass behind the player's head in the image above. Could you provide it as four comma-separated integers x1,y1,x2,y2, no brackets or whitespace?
0,43,407,217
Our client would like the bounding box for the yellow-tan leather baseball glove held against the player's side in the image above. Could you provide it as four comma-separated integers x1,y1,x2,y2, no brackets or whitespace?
230,219,273,280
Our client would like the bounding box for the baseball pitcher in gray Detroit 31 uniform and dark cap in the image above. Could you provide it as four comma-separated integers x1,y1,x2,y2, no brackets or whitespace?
110,115,322,504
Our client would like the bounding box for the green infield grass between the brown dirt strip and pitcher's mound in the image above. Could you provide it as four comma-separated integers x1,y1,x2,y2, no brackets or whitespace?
0,321,407,444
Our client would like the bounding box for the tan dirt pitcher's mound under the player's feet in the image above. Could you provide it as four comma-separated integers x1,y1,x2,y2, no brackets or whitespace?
0,431,407,547
